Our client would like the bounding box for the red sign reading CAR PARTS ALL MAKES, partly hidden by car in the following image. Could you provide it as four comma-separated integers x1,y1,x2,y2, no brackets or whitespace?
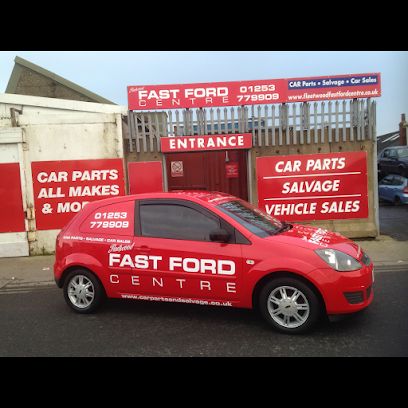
31,159,125,230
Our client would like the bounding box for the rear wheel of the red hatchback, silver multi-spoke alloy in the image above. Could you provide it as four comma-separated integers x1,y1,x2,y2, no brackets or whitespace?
63,269,105,313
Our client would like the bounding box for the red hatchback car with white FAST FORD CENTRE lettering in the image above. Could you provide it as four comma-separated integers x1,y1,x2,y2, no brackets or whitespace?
54,191,374,333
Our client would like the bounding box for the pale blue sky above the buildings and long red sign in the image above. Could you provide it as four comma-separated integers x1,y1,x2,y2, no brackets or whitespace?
0,51,408,135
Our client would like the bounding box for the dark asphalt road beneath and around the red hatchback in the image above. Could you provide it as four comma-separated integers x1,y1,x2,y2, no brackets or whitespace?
0,270,408,357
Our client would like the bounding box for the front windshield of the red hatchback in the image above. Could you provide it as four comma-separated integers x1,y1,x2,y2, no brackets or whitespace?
217,200,292,238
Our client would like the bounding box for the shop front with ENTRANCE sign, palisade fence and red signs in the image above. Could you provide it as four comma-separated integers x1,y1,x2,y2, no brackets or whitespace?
124,73,381,238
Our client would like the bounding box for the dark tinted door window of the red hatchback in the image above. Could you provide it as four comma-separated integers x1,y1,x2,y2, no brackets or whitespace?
139,203,220,241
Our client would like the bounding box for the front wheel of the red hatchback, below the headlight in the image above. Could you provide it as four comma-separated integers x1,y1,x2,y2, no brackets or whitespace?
259,277,322,334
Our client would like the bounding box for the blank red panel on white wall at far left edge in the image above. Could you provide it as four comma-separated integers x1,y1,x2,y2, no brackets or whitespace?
0,163,25,232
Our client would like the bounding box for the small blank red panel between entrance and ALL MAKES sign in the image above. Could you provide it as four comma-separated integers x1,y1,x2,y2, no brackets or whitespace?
128,161,163,194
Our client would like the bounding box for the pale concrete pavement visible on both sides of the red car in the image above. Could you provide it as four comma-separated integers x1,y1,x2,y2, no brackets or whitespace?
0,235,408,292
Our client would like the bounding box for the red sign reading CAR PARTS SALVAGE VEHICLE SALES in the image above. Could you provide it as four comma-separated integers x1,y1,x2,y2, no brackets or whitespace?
256,152,368,221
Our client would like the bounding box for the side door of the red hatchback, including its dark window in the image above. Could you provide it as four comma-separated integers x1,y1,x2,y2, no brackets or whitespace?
132,199,242,305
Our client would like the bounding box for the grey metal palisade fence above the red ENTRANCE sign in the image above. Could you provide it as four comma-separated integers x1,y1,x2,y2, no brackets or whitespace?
125,99,376,152
